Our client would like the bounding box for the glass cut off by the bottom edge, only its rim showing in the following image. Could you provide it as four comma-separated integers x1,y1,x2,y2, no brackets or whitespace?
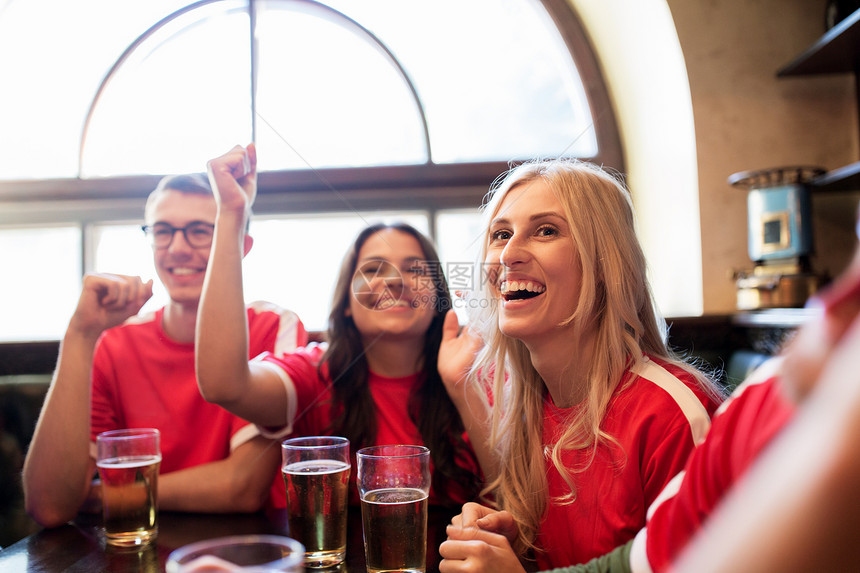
165,535,305,573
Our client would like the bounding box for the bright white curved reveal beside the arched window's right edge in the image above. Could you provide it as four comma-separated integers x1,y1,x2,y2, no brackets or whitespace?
570,0,703,316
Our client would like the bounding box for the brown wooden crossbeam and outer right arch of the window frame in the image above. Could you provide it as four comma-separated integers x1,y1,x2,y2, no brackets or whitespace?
0,0,625,212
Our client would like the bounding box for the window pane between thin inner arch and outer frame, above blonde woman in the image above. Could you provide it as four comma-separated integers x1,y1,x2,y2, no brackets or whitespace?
327,0,601,163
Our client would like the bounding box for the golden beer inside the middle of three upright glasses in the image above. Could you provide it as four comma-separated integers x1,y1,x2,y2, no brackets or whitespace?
282,459,350,567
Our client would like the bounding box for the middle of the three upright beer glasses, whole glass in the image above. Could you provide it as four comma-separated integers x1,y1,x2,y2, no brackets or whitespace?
281,436,351,568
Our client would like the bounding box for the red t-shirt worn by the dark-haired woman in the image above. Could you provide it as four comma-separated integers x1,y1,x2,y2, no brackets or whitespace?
260,344,480,504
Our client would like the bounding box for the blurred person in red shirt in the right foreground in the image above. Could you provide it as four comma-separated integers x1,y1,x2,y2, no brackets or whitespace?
441,201,860,573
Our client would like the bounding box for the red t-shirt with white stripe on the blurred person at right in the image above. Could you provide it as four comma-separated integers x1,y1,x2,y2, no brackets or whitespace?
630,359,795,572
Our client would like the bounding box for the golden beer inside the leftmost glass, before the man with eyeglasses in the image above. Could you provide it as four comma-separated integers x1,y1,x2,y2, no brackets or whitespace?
97,455,161,546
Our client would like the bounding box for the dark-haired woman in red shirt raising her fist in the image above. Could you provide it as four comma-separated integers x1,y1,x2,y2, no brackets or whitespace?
197,145,481,505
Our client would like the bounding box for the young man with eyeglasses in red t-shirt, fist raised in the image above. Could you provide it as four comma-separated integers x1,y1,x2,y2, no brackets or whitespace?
23,175,307,527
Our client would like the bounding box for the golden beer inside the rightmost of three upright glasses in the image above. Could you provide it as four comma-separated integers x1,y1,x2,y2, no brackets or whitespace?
361,488,427,573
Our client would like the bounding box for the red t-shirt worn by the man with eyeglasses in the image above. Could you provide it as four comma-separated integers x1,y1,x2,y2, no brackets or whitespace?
90,304,307,507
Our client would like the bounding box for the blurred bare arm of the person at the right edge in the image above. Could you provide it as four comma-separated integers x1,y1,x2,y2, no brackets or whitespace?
672,217,860,573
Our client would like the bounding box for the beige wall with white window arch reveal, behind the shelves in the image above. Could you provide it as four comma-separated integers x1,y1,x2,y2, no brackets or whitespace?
568,0,860,316
